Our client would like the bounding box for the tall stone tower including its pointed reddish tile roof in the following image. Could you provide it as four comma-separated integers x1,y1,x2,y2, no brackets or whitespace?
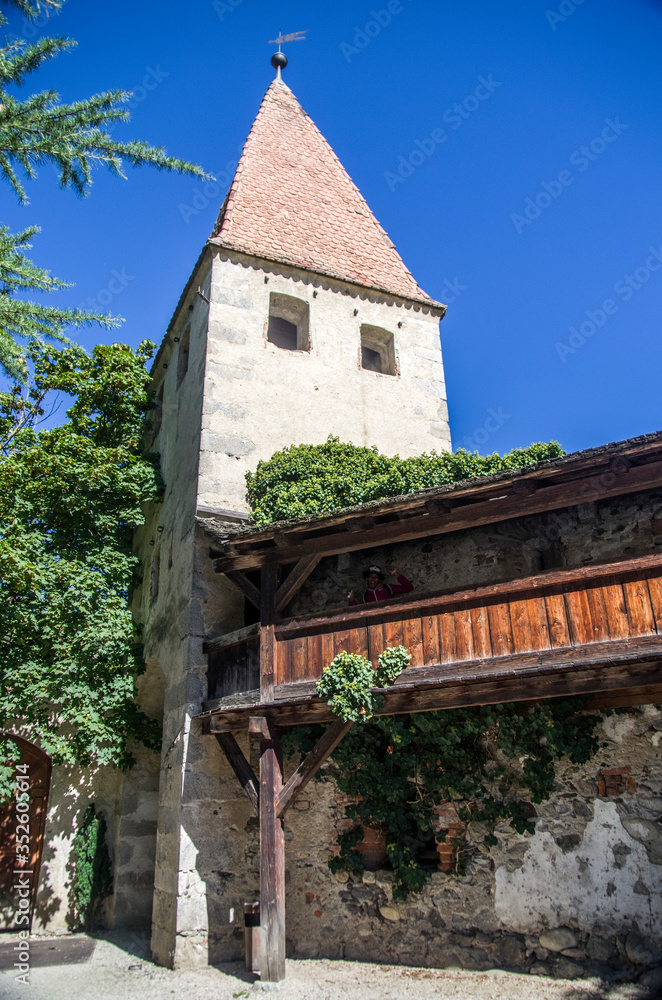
128,72,450,967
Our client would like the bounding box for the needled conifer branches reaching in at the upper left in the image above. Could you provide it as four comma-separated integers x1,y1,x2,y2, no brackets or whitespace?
0,0,206,379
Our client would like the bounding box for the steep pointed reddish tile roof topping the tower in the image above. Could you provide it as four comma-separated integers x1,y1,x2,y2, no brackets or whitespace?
210,80,436,305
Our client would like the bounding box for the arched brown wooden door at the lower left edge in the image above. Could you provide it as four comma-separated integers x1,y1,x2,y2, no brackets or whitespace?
0,733,52,931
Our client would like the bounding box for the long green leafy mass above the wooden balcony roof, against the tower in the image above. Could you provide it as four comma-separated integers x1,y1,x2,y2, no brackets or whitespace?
246,437,564,524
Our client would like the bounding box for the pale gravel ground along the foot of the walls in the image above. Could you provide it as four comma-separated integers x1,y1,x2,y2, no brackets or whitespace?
0,934,662,1000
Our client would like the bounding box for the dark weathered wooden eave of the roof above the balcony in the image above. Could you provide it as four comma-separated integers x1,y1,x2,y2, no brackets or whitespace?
203,432,662,573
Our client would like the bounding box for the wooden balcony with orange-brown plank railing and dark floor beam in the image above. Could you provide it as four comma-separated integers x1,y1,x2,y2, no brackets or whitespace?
207,555,662,731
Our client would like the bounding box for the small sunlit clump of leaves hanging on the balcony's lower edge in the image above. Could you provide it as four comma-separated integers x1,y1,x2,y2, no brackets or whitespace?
315,646,411,722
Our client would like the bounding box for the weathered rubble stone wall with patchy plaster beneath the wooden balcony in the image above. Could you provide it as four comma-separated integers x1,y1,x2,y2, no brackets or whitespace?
197,706,662,978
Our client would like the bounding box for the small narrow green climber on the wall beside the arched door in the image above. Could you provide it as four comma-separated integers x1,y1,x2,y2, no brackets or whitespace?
71,802,113,930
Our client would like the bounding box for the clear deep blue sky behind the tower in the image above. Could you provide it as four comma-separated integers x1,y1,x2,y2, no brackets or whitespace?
3,0,662,453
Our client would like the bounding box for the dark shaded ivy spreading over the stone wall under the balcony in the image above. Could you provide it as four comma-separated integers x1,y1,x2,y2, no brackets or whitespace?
288,698,600,899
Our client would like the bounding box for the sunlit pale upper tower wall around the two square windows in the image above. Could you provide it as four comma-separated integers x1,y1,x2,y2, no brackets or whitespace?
198,253,450,510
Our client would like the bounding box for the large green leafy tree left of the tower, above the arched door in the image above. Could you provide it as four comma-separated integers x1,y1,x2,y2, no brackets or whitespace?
0,342,161,767
